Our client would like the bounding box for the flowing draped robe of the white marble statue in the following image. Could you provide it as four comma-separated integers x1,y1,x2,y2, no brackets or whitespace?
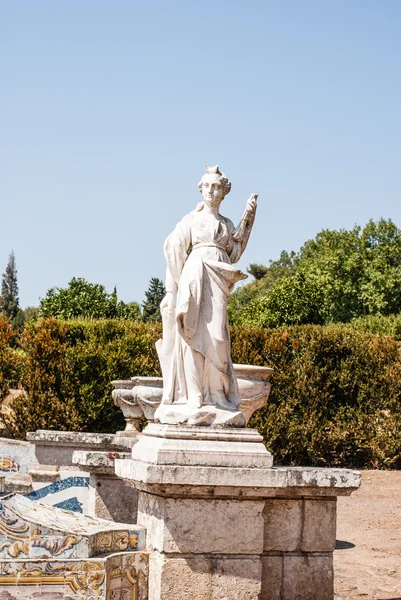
157,204,250,409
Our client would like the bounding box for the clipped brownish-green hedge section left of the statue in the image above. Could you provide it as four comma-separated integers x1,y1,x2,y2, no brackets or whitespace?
6,319,160,439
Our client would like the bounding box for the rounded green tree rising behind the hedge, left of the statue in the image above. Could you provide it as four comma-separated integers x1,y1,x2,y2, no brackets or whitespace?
40,277,140,320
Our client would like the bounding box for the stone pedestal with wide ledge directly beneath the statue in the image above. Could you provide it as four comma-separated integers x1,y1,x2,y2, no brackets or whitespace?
116,424,360,600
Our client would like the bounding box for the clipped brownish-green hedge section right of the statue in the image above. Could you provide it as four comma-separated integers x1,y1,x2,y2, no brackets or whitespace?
228,325,401,468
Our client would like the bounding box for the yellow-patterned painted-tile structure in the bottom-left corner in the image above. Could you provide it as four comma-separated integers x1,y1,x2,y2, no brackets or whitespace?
0,494,148,600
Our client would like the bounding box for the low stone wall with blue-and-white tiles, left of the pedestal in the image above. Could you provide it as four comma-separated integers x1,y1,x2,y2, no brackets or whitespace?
0,430,136,522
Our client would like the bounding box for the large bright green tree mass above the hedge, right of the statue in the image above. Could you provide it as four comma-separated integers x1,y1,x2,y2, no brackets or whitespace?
229,219,401,327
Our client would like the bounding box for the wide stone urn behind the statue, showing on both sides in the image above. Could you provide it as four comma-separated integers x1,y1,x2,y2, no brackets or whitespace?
111,365,273,436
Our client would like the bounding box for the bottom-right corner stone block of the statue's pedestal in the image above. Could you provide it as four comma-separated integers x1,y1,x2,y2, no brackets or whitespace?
280,554,334,600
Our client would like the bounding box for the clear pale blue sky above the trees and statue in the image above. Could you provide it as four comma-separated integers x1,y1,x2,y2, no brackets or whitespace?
0,0,401,307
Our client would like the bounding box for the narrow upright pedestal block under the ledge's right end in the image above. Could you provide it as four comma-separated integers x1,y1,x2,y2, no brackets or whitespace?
301,499,337,552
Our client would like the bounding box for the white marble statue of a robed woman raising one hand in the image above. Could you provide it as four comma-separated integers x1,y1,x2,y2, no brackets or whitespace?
155,165,257,426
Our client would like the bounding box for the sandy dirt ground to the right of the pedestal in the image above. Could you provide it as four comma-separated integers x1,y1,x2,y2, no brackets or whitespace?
334,471,401,600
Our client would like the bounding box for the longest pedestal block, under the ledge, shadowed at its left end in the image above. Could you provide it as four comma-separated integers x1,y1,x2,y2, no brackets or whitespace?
138,493,264,554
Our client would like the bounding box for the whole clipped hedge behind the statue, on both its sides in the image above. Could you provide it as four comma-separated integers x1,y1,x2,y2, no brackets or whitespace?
0,319,401,468
